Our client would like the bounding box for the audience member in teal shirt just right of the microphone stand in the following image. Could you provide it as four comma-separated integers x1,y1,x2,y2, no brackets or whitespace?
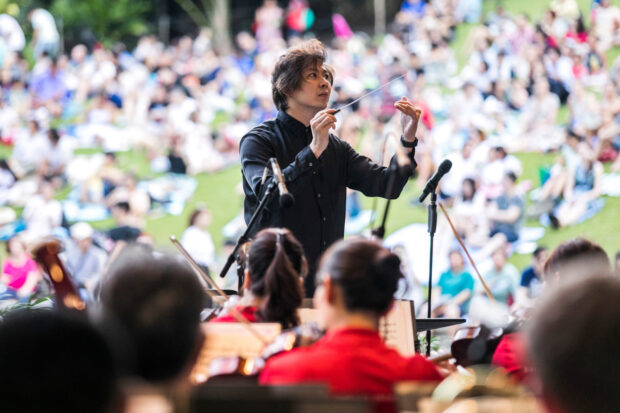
433,250,474,318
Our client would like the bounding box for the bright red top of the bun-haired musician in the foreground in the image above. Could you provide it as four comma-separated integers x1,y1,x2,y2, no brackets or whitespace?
259,328,442,395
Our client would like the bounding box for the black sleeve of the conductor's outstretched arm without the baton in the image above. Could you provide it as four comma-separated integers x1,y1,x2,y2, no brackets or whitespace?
341,141,416,199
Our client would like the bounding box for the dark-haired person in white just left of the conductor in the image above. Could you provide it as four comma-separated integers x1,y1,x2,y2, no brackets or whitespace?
181,207,215,274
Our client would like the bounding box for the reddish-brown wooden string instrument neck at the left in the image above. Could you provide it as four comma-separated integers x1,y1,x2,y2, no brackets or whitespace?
31,239,86,311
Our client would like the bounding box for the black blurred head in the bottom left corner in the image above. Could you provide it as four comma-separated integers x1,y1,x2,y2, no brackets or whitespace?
0,310,116,413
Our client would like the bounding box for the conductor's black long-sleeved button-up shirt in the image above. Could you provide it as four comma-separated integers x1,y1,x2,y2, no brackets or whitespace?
239,111,415,295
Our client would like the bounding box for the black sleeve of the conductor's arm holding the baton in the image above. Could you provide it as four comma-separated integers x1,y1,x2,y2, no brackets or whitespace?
239,135,321,197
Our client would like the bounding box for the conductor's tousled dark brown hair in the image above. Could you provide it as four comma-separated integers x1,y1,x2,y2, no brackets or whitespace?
271,39,334,111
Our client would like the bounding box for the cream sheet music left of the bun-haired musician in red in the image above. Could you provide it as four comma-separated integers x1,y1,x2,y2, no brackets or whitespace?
190,323,282,383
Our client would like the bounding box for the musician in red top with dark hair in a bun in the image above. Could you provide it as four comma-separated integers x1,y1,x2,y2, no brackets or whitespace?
259,239,442,396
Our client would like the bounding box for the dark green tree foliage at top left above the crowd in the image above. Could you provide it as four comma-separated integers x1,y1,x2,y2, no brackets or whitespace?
51,0,154,46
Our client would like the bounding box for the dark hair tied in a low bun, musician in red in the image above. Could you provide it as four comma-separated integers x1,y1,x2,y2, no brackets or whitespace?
317,239,403,316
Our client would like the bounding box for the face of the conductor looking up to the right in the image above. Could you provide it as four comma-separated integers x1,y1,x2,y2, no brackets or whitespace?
288,64,332,112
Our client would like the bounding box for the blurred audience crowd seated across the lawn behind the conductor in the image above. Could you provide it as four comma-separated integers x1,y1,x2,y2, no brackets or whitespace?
0,0,620,308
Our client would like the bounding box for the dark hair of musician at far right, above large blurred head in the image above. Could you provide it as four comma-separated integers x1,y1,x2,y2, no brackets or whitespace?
543,237,611,278
